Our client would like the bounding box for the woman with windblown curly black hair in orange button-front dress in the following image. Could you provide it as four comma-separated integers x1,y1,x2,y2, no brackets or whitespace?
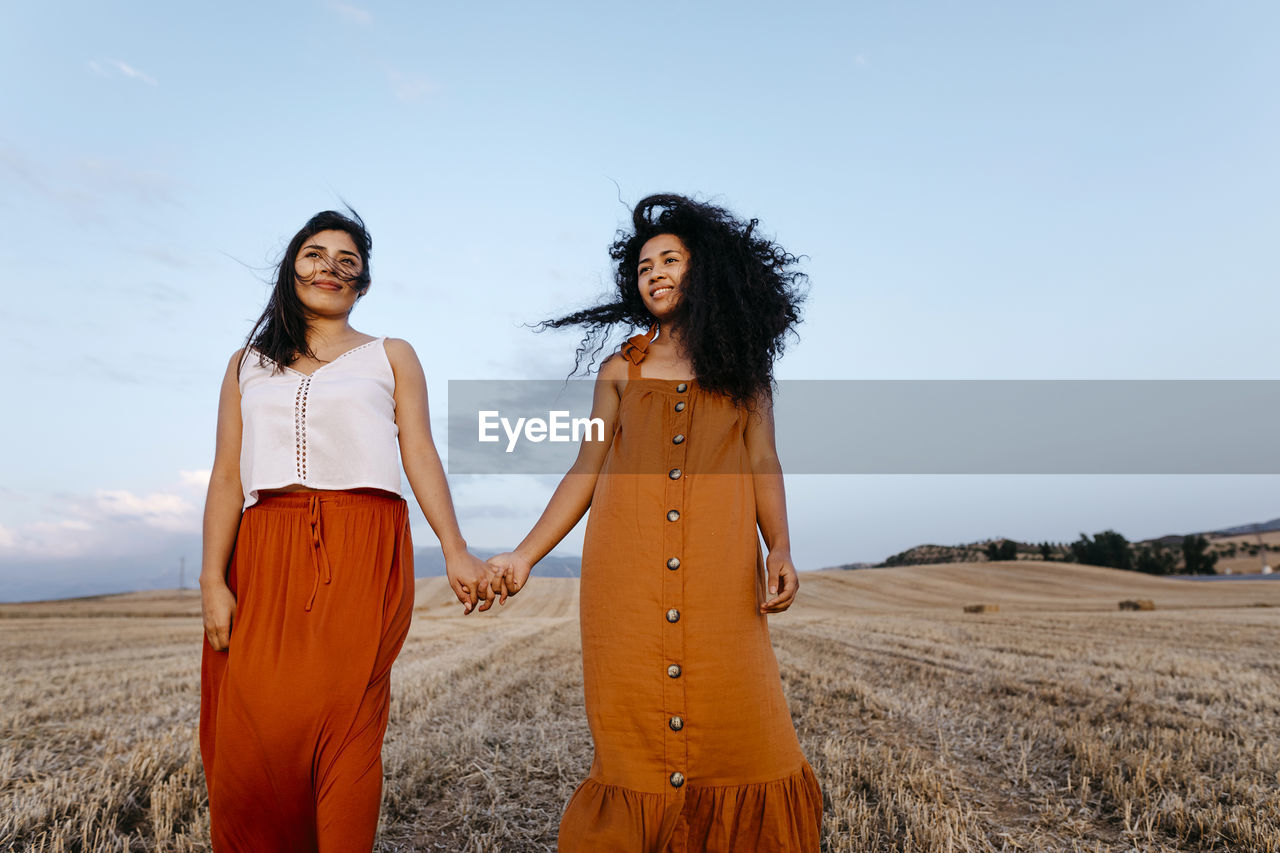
490,195,822,853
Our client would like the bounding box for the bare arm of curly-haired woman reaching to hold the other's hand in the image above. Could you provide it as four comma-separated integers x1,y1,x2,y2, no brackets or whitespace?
489,356,626,599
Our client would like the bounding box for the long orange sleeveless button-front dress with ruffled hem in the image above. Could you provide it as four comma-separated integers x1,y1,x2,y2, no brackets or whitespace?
559,334,822,853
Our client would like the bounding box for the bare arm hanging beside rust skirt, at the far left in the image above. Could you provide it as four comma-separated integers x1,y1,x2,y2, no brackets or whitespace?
200,350,244,652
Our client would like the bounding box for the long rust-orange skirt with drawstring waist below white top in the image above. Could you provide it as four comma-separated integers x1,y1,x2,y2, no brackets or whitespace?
200,492,413,852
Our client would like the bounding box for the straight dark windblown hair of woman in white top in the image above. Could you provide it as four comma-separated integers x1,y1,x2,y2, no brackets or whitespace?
236,207,374,375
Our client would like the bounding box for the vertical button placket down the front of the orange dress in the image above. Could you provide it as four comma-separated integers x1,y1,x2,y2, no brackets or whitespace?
654,383,694,788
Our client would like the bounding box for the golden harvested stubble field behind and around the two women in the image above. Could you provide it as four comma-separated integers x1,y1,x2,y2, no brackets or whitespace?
0,561,1280,853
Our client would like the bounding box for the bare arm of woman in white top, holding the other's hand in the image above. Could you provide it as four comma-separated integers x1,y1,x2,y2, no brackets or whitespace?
387,338,493,612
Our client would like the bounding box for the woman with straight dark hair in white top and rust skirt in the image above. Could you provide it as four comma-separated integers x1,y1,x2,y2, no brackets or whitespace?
200,210,493,853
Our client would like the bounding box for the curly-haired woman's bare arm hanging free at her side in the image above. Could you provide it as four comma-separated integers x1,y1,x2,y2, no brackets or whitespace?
745,393,800,613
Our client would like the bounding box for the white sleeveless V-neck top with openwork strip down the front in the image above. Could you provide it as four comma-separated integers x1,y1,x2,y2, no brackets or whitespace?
239,338,401,510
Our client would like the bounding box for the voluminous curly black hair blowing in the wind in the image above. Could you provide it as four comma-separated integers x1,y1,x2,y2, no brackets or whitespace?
539,193,808,405
